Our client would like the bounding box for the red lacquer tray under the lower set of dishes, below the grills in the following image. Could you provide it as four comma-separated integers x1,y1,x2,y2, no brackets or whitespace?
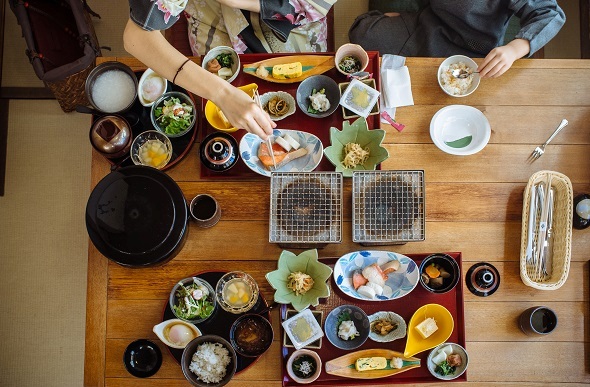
281,253,469,386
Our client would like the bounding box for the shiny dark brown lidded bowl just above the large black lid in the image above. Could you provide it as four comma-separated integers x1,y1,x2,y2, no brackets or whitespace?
90,115,132,159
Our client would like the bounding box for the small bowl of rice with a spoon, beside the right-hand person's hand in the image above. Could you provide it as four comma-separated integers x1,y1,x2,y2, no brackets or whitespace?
438,55,480,97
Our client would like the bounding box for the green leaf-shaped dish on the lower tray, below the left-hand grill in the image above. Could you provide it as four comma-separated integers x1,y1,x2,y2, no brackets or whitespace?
266,250,332,311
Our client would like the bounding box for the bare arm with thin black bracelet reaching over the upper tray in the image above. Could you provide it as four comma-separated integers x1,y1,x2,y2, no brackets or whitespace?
123,20,276,139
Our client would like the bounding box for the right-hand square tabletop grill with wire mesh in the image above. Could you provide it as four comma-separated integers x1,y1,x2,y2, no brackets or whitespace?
352,171,426,245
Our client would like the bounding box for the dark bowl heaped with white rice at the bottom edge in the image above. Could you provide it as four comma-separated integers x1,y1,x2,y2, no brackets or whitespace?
180,335,238,387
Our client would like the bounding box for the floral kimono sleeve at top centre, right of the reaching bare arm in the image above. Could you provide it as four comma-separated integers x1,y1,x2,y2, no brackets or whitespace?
260,0,336,41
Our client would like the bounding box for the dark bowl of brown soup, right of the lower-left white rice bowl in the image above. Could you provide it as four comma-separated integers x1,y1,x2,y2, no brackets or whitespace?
229,314,274,357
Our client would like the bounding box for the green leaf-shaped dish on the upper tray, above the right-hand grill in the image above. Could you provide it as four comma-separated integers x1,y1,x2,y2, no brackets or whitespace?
324,117,389,177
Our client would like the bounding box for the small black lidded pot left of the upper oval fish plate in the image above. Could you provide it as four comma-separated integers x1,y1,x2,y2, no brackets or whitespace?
199,132,239,172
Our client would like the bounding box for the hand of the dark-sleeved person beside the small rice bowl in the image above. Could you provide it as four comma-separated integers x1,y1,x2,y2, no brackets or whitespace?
477,39,531,78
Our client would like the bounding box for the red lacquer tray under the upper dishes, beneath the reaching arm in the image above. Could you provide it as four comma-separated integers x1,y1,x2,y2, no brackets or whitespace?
199,51,381,178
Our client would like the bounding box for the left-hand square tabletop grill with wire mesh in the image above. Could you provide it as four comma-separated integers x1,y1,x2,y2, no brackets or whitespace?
269,172,342,244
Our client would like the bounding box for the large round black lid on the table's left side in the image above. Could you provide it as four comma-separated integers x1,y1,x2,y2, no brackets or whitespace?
86,166,188,266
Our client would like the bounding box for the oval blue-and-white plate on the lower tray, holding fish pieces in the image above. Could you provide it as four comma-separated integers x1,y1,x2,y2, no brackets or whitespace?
334,251,420,301
